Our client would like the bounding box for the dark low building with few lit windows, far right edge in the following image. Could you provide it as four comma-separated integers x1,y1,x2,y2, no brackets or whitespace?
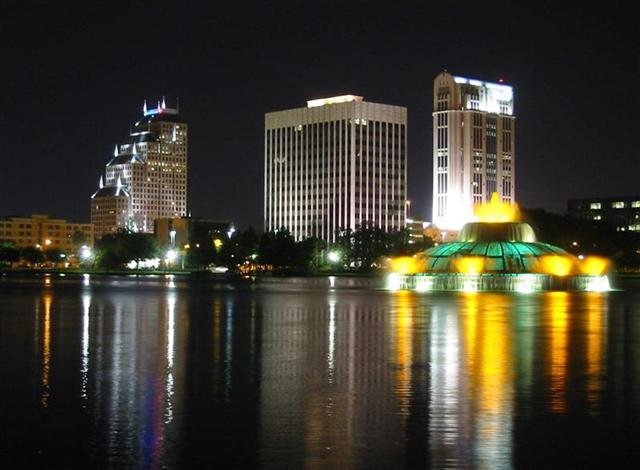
568,196,640,232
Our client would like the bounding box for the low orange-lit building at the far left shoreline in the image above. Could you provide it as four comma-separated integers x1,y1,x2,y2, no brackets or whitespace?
0,214,93,253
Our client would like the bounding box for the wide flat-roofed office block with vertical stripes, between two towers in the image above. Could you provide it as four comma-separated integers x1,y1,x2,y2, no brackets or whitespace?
264,95,407,241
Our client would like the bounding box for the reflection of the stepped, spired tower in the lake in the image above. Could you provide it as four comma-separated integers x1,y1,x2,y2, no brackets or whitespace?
74,292,186,466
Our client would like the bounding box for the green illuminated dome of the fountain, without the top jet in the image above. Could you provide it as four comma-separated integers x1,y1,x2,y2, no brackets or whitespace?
423,222,572,274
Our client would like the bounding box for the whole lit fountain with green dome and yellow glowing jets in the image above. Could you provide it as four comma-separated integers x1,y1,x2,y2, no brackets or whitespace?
388,193,609,292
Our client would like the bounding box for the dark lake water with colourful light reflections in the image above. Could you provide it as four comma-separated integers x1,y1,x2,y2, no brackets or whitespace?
0,277,640,469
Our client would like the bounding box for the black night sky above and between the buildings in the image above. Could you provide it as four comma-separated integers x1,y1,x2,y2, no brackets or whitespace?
0,0,640,228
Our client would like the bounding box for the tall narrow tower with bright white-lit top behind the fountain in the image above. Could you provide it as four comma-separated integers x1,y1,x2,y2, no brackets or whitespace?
433,71,515,230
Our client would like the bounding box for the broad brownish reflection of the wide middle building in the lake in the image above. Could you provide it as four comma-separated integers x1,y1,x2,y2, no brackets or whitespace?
260,292,402,468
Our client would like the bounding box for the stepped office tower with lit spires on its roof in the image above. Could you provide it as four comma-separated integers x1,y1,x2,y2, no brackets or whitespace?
91,98,187,238
